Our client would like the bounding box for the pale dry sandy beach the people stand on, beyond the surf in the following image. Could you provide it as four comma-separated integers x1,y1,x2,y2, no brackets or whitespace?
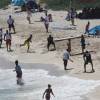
0,7,100,100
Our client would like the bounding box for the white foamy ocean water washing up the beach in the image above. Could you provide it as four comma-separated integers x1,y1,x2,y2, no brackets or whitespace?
0,69,100,100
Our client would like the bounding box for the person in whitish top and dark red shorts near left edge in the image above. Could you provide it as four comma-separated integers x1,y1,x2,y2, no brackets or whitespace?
4,30,12,51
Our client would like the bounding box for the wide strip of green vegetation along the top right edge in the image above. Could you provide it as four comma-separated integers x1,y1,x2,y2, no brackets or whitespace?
40,0,100,10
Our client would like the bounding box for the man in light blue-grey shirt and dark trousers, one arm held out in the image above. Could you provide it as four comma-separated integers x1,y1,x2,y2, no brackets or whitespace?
63,49,73,70
